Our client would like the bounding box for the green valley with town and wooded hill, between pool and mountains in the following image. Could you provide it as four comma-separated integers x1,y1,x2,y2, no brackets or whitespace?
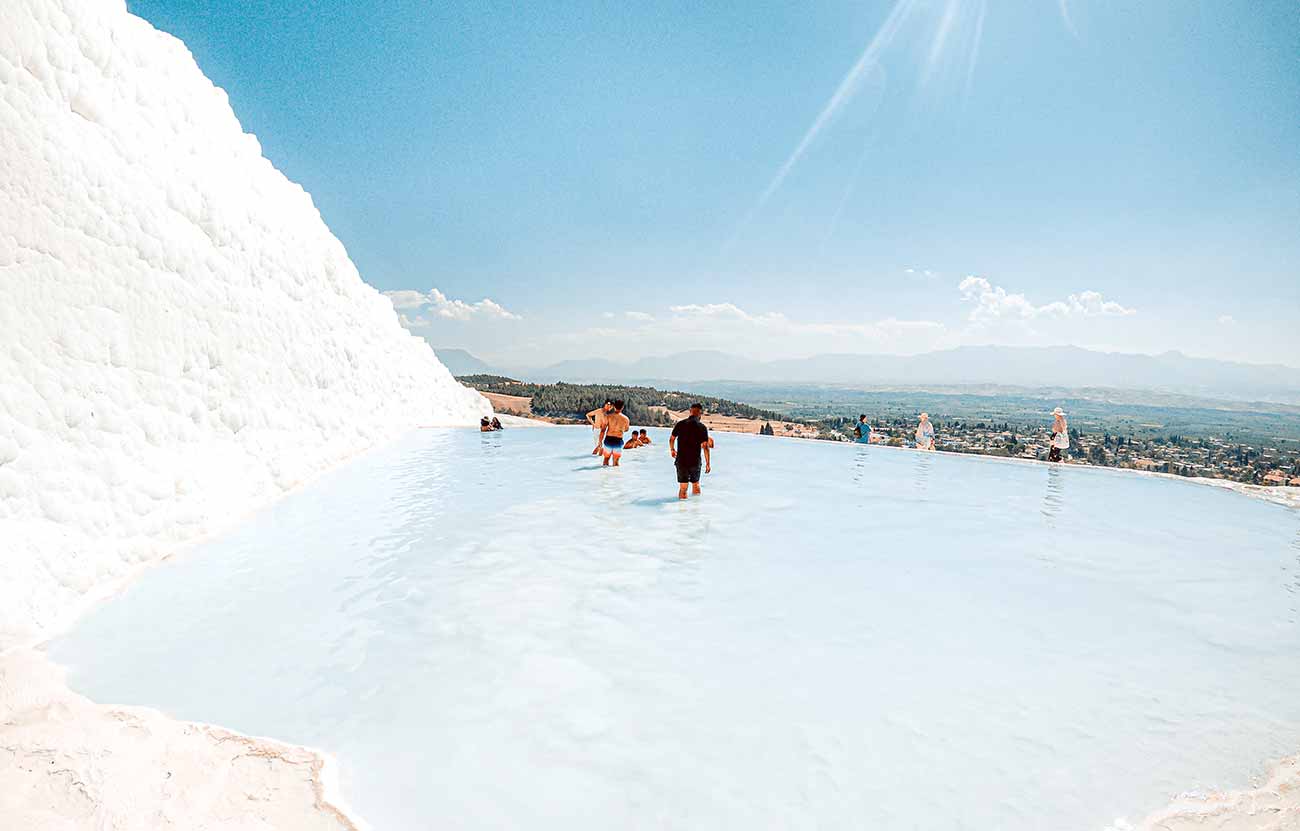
460,375,1300,486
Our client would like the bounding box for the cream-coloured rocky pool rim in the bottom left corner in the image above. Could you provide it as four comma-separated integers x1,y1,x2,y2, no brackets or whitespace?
0,649,369,831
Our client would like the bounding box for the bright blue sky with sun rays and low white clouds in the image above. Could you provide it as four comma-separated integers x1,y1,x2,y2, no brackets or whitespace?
127,0,1300,364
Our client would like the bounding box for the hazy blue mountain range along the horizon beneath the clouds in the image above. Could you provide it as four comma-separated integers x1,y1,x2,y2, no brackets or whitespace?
437,346,1300,403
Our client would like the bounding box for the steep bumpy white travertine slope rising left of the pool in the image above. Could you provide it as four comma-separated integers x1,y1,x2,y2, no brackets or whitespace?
0,0,490,650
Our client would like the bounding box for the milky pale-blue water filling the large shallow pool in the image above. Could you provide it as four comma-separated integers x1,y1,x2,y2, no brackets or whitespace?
52,428,1300,831
